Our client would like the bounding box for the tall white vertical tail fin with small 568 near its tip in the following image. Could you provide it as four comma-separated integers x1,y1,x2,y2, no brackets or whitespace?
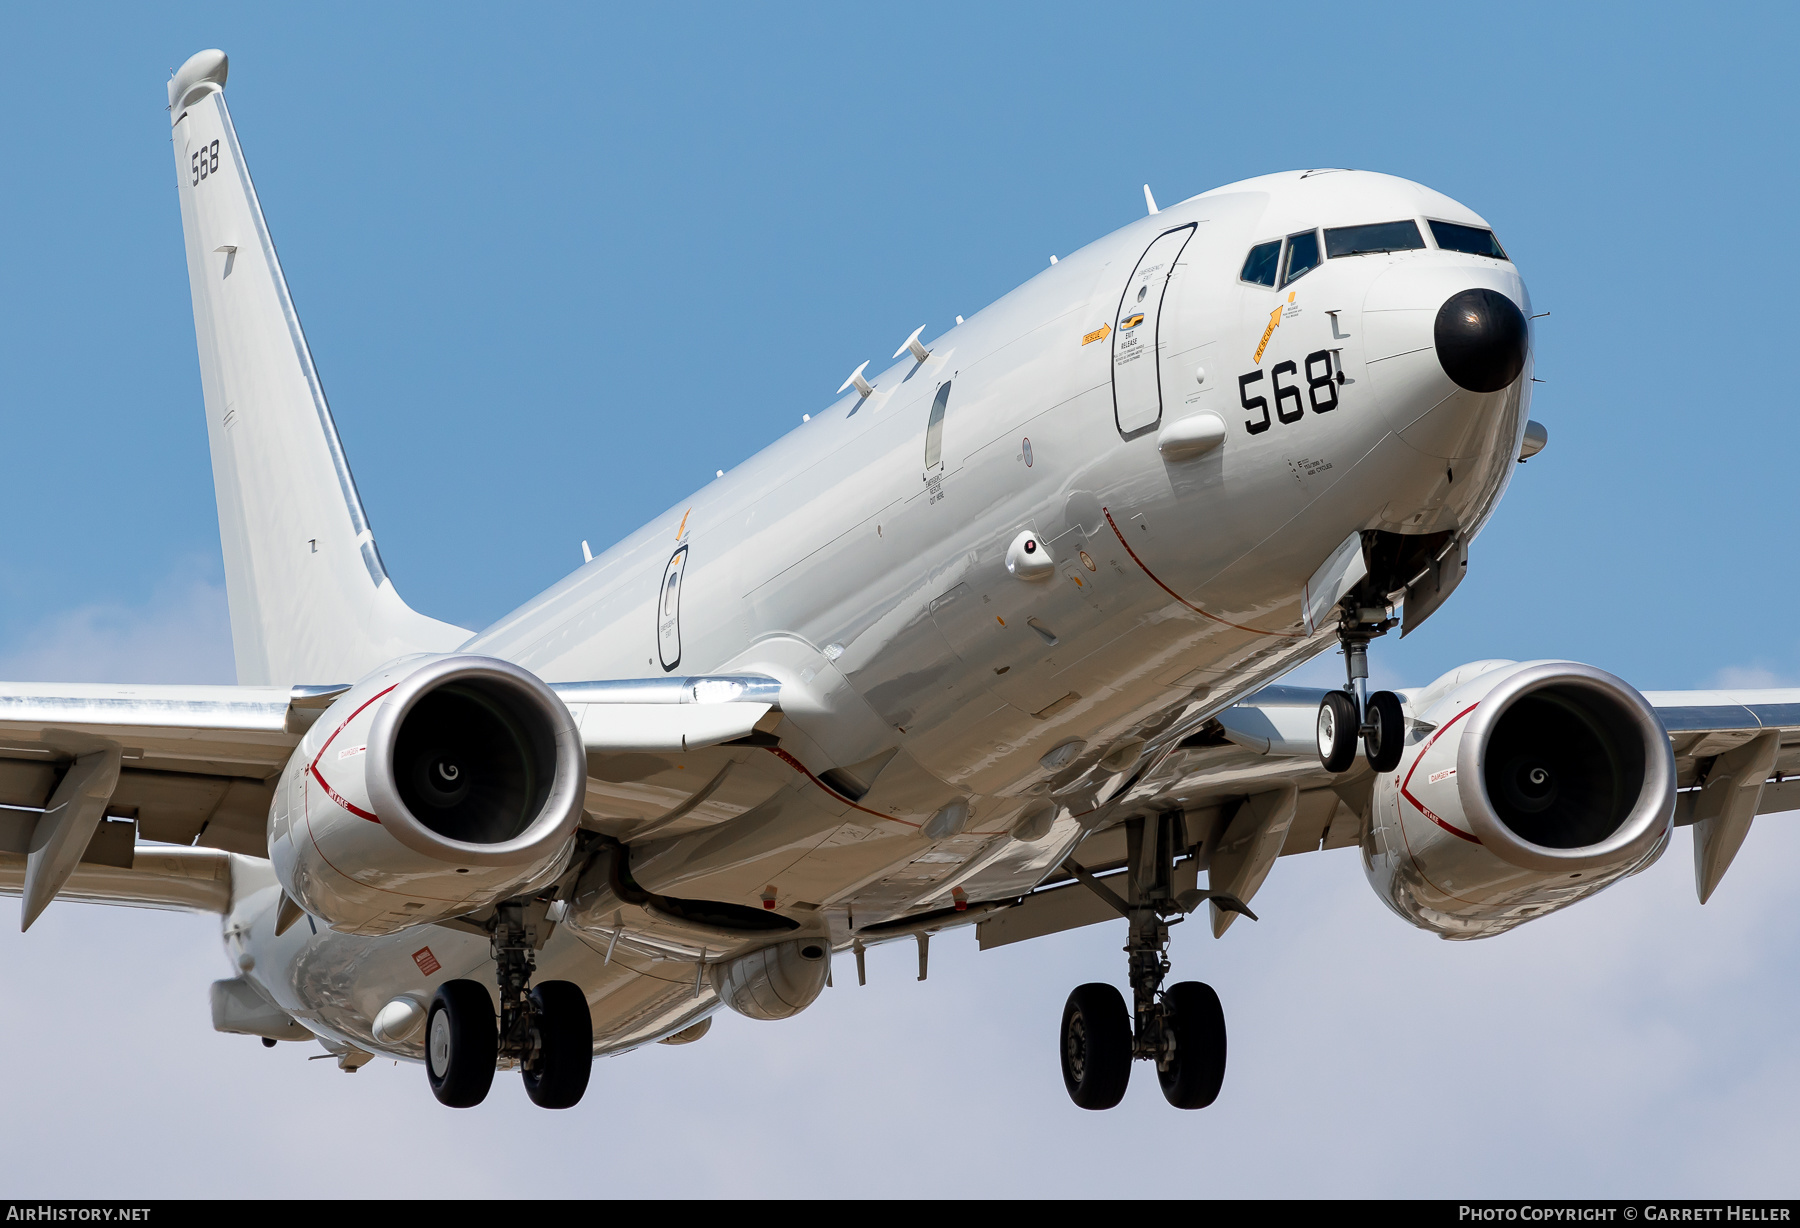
169,50,470,684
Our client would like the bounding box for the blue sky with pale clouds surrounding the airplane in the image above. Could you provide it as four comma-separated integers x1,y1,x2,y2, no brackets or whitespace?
0,4,1800,1197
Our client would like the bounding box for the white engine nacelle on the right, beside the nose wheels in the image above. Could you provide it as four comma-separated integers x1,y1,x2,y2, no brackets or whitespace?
1363,661,1676,938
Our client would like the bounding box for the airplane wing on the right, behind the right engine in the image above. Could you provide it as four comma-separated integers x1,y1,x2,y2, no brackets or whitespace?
977,686,1800,949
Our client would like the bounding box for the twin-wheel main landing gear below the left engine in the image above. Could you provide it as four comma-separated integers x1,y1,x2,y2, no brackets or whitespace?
425,900,594,1109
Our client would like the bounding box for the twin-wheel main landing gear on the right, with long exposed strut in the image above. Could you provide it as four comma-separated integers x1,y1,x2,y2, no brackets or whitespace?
1060,814,1249,1109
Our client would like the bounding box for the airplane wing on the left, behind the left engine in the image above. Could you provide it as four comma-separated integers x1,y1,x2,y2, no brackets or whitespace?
0,677,779,926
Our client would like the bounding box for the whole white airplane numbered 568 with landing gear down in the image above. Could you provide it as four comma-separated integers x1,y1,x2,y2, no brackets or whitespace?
0,50,1800,1109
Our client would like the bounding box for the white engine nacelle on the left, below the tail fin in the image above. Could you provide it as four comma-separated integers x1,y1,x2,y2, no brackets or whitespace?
268,655,587,935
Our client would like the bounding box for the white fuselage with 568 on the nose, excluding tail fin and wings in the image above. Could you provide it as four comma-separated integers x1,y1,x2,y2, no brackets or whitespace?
229,171,1530,1057
